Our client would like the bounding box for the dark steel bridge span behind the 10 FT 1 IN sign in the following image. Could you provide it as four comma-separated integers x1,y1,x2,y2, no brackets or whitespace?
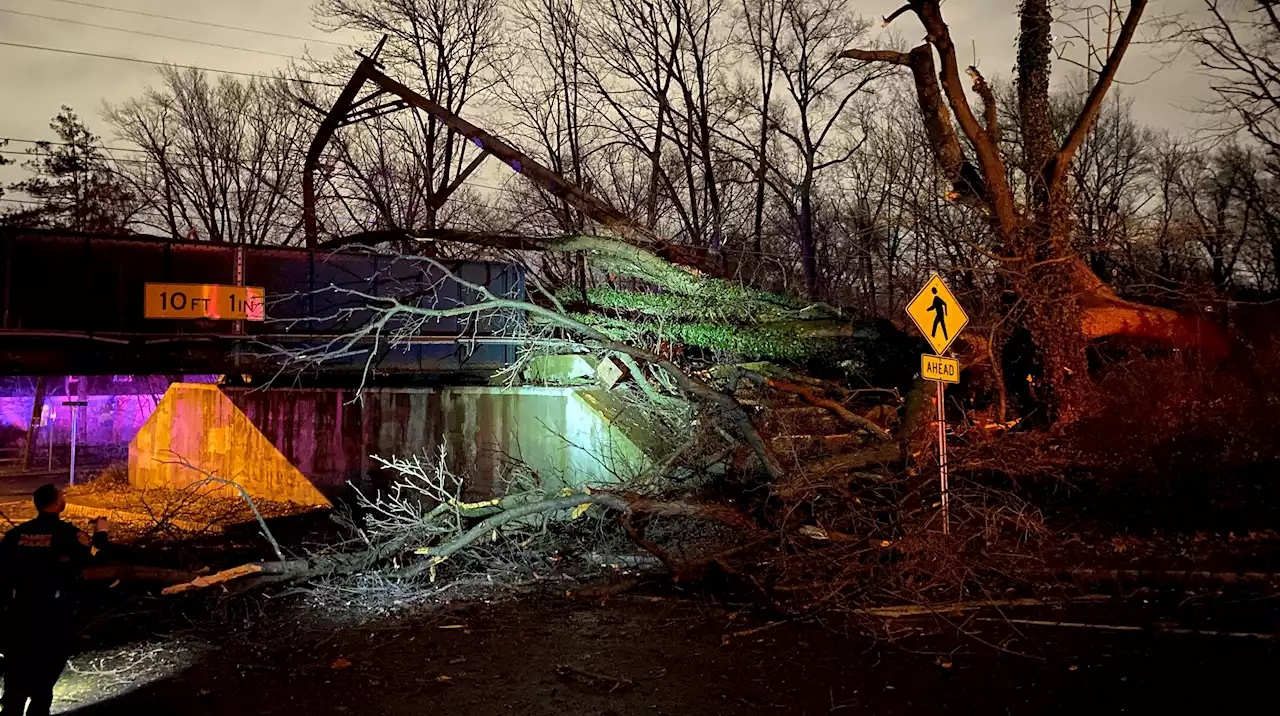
0,229,525,375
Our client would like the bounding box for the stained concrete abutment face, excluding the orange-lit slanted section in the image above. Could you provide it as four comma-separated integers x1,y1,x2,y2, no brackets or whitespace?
224,387,648,496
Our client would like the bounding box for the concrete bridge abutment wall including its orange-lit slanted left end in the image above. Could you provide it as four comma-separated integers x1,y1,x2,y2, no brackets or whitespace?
129,384,652,498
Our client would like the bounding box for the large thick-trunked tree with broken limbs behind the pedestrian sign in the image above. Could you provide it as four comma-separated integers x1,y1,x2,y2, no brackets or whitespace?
842,0,1226,423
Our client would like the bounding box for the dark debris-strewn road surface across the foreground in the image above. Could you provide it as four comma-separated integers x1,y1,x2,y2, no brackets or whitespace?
45,594,1280,716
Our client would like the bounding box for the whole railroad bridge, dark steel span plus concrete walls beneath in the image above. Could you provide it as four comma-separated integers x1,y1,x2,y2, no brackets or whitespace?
0,231,648,503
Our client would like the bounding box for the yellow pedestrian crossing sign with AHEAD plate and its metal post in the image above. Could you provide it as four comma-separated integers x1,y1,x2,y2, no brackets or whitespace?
906,274,969,534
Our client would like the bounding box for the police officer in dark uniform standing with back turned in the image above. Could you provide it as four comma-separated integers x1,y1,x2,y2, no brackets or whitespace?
0,484,108,716
